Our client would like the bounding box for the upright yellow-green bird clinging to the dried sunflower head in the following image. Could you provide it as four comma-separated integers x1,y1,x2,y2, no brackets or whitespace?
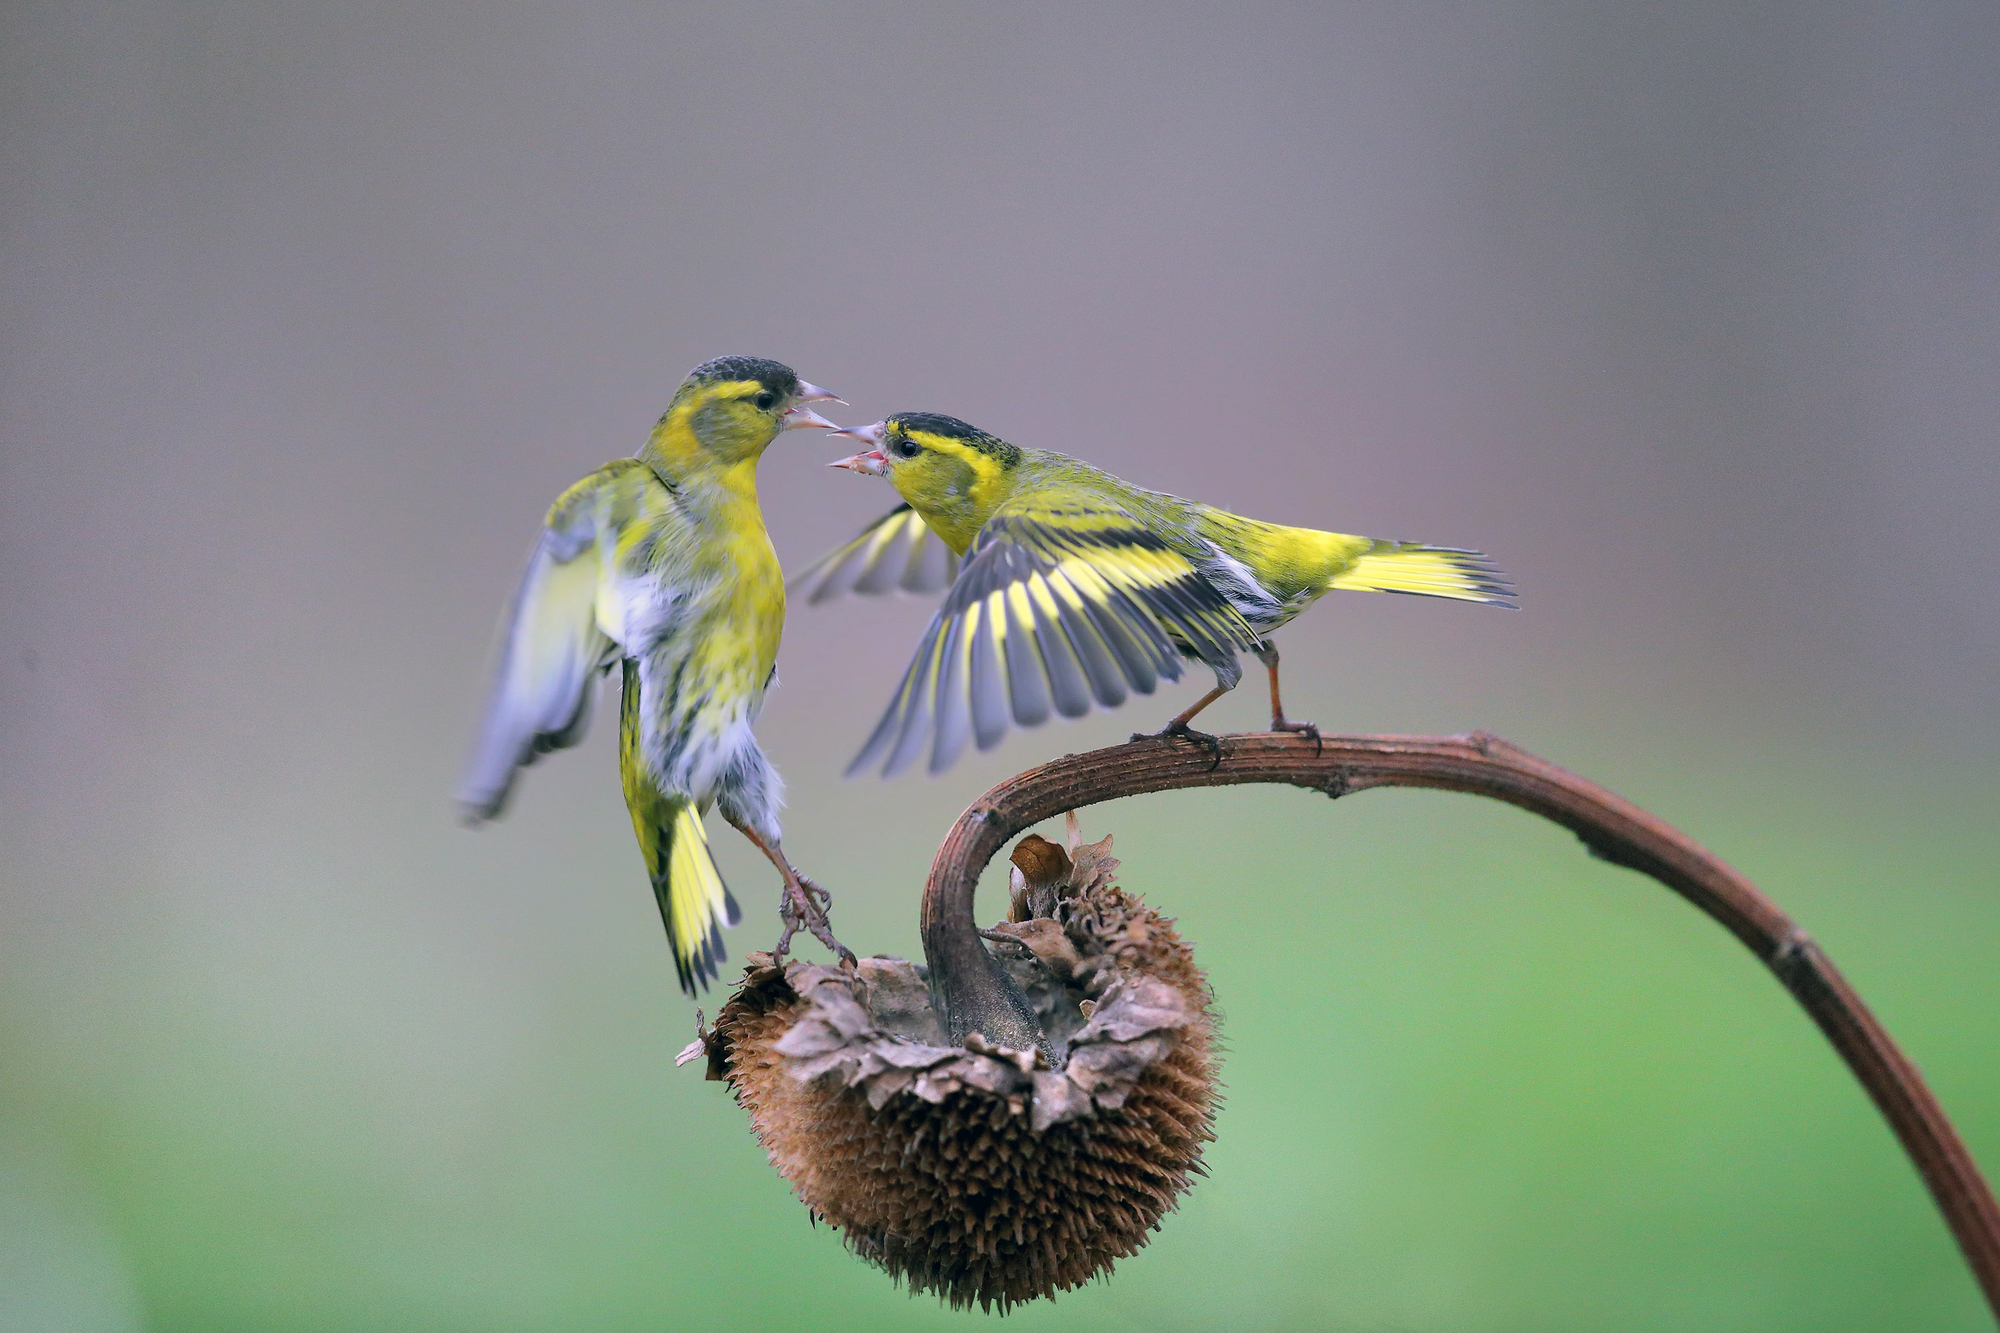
458,356,844,995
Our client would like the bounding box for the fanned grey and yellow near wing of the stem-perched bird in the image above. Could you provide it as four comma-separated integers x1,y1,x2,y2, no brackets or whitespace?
848,492,1256,775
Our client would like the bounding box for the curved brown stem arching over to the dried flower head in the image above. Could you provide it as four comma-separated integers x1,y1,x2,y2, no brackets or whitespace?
922,733,2000,1317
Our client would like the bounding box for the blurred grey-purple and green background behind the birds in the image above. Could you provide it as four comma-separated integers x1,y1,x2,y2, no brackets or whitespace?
0,0,2000,1333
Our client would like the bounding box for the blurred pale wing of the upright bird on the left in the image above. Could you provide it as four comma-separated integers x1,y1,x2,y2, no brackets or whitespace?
458,472,616,821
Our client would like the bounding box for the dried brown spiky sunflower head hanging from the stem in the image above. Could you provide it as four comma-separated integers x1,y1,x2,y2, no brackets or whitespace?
712,819,1218,1311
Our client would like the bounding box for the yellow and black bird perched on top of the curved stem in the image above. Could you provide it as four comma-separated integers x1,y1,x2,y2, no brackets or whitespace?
800,412,1514,773
